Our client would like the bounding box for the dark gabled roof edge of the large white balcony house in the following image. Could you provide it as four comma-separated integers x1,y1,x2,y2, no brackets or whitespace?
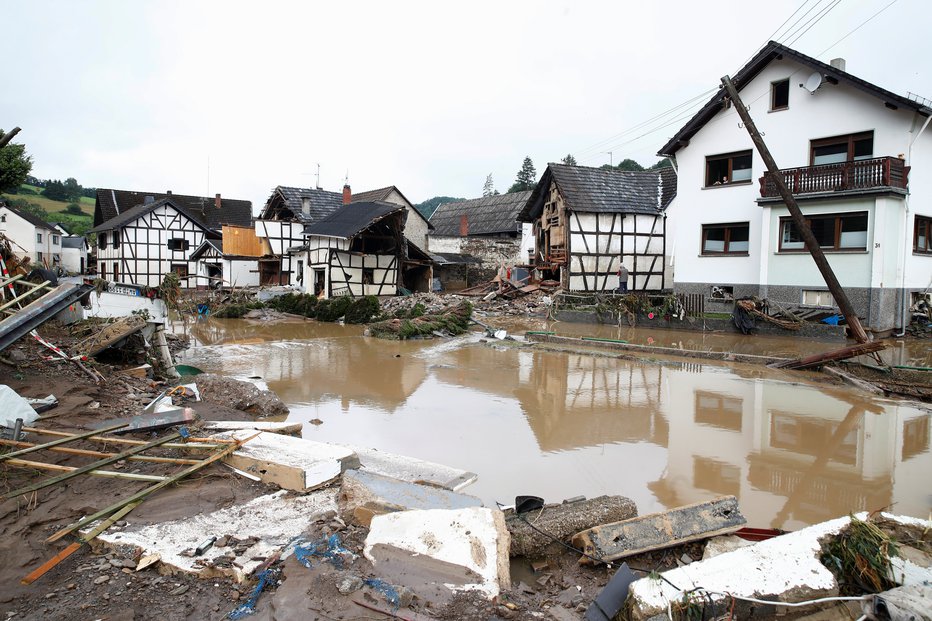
658,41,932,157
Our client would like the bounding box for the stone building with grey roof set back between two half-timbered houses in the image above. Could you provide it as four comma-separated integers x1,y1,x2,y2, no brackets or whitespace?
430,191,532,289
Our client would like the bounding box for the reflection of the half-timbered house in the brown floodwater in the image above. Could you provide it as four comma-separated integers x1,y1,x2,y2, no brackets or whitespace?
435,347,667,452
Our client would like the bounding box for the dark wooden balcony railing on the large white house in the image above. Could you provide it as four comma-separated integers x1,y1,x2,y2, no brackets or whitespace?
760,157,909,198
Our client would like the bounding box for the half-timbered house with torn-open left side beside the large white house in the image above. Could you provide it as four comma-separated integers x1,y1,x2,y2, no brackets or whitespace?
518,164,676,292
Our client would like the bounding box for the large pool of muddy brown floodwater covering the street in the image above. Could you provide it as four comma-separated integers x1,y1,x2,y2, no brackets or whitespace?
180,319,932,530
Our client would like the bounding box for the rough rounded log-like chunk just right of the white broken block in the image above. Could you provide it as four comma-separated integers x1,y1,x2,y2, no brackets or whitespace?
505,496,638,557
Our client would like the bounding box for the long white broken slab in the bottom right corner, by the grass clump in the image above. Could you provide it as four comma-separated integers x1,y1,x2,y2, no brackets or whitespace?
630,513,932,621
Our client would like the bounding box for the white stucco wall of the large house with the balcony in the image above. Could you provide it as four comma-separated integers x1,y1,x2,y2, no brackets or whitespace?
667,54,932,298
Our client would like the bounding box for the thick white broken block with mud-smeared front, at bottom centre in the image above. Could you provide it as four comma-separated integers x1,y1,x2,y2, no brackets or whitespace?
364,507,511,601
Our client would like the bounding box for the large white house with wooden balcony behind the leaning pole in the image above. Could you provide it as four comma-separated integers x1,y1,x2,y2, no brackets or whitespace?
659,41,932,332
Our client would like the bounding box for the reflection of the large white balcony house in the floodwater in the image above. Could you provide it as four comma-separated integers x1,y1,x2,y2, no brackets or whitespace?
651,373,930,529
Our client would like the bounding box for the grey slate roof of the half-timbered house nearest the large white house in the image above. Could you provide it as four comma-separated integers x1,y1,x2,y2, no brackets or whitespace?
518,164,676,222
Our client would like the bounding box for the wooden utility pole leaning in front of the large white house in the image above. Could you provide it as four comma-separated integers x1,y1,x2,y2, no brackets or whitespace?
722,75,869,343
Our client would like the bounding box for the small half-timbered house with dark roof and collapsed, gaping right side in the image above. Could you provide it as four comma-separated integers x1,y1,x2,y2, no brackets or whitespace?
299,203,408,298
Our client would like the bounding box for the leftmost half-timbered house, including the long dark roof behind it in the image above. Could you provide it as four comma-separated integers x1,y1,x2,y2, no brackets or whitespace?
89,189,252,288
